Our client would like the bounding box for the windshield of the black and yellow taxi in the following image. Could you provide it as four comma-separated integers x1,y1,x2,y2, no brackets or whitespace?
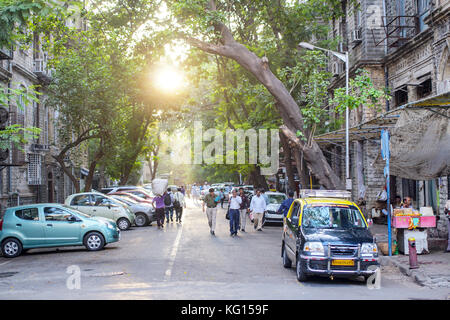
302,205,366,229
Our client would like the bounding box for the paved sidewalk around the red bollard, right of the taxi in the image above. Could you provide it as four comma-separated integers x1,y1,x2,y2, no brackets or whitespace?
370,224,450,288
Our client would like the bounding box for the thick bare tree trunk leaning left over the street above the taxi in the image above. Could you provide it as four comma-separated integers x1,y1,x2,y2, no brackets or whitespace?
186,0,344,189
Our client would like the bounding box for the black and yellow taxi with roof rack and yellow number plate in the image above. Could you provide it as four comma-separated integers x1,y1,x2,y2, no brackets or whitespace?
281,190,379,281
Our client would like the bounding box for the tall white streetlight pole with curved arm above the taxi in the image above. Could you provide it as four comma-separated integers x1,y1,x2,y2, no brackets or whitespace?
298,42,352,190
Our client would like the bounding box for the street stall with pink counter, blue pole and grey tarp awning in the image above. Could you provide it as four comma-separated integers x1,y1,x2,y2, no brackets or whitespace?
315,92,450,255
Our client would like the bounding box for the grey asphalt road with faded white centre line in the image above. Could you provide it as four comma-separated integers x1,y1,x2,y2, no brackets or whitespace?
0,202,450,300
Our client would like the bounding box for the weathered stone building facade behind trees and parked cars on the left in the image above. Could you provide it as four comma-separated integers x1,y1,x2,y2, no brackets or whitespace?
0,30,86,213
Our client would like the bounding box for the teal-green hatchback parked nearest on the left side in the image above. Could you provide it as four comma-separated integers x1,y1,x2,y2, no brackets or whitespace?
0,203,120,258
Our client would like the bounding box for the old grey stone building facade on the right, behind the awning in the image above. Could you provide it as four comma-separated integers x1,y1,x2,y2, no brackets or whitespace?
317,0,450,238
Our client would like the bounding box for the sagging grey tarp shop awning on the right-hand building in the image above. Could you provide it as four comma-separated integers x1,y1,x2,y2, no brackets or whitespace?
315,92,450,180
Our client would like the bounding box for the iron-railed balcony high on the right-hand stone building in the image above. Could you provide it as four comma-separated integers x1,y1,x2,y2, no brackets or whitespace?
372,16,419,48
